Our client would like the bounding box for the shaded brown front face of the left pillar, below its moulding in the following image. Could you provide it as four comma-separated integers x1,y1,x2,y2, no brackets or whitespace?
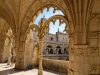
15,41,26,69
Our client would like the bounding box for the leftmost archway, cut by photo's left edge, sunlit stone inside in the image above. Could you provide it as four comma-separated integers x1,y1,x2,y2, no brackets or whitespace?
0,17,16,66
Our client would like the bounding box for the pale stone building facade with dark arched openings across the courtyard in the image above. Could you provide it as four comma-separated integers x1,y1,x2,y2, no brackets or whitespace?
33,28,69,55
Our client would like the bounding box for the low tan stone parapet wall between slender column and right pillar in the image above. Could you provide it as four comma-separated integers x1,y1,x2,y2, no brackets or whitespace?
43,59,69,73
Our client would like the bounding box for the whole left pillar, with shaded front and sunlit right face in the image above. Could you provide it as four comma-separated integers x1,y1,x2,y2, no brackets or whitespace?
15,30,33,69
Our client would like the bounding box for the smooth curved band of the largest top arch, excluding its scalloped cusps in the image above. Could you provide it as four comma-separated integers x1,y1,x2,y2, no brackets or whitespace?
21,2,73,40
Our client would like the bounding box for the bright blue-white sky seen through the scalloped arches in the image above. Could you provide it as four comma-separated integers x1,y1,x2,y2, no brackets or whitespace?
34,7,65,34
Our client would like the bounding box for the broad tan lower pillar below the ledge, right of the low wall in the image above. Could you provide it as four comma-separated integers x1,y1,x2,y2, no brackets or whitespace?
70,45,90,75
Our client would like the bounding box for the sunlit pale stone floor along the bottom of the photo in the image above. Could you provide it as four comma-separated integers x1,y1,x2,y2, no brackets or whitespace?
0,64,64,75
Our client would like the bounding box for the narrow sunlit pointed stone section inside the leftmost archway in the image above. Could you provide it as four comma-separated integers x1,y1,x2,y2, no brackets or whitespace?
3,28,16,63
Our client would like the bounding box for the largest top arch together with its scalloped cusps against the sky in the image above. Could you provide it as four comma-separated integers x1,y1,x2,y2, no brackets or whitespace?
21,1,71,37
